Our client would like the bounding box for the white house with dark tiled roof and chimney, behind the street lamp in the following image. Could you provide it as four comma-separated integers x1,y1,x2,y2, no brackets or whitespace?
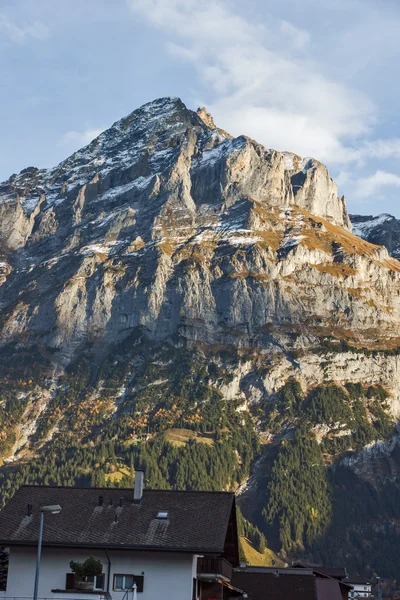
0,471,245,600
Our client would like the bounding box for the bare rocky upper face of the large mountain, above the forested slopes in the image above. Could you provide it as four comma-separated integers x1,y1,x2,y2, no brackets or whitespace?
0,98,400,360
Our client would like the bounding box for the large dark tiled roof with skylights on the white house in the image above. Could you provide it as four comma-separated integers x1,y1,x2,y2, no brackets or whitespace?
0,486,234,553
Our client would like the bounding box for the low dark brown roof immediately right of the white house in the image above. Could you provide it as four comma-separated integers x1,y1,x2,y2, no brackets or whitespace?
232,569,318,600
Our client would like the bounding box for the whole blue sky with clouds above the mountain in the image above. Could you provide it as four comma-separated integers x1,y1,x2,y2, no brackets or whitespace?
0,0,400,217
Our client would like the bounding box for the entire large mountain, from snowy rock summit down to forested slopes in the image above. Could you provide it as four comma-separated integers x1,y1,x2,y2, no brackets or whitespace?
0,98,400,574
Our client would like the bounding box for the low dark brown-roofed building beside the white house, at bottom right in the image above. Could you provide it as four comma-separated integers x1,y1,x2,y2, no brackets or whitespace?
232,567,351,600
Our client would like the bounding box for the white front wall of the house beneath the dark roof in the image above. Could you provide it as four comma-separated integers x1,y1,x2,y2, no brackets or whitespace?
0,547,196,600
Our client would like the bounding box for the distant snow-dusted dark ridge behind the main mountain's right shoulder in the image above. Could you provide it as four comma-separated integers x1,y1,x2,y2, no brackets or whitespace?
350,214,400,259
